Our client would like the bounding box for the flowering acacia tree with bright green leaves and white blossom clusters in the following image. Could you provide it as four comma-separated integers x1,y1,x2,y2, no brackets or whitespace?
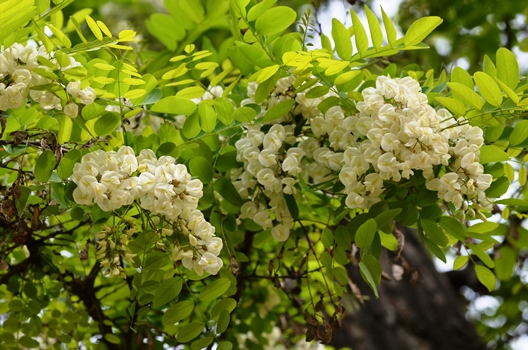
0,0,528,349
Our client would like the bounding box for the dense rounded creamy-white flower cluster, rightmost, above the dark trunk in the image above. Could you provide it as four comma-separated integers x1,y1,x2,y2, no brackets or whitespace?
352,76,492,210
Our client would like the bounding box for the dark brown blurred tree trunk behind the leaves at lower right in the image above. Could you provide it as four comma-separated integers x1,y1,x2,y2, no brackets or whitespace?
331,227,485,350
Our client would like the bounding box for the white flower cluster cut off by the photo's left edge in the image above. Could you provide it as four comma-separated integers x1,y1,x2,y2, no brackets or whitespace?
0,43,95,118
